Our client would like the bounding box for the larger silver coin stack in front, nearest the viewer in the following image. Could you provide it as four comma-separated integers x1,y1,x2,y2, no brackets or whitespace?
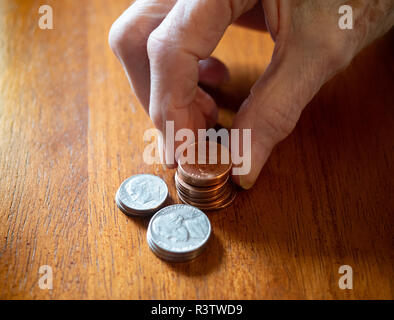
147,204,211,262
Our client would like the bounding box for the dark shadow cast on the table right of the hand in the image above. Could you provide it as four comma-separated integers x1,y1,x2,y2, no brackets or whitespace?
206,31,394,260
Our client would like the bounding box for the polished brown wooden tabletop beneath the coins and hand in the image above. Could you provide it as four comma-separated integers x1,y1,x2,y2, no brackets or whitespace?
0,0,394,299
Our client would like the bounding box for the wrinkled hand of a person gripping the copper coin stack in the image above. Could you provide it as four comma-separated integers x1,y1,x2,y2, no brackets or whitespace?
109,0,394,189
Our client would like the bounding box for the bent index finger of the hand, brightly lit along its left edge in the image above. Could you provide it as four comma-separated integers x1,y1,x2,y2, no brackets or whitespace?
148,0,257,162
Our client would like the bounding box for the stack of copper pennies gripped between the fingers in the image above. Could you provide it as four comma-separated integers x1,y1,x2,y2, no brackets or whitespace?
175,141,236,210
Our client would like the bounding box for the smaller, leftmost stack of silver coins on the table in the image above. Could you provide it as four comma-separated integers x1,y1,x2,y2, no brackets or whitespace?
115,174,168,215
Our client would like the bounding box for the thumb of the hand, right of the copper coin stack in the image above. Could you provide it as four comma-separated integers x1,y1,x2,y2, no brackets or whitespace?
231,46,340,189
